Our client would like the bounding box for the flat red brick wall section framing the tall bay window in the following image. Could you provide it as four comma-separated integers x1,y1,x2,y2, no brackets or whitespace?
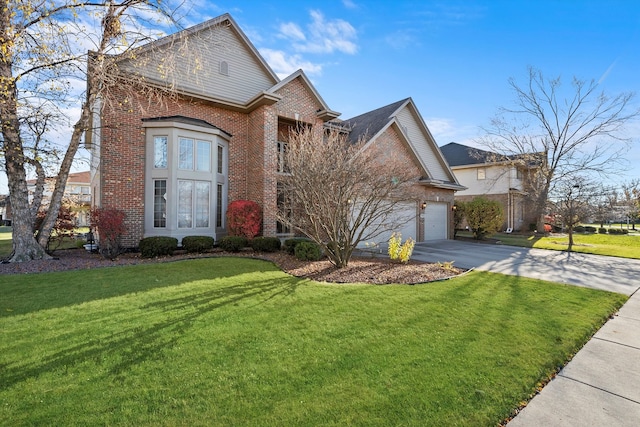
98,88,249,247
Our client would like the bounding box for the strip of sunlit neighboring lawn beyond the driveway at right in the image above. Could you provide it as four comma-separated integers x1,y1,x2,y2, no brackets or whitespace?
458,232,640,259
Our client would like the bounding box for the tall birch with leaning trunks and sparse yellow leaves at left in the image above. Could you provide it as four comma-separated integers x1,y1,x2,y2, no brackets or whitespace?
0,0,188,261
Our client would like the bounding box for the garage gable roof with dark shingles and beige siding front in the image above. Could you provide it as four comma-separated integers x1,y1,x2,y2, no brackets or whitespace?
340,98,466,190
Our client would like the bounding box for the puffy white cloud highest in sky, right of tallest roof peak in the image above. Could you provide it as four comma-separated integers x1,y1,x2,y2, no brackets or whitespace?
280,10,358,55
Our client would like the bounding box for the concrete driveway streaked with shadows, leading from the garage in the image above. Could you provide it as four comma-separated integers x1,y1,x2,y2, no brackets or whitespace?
412,240,640,295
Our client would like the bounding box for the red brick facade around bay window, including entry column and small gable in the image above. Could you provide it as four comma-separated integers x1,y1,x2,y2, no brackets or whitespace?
98,75,330,247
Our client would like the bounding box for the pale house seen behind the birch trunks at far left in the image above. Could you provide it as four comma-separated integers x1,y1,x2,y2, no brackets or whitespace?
27,171,91,227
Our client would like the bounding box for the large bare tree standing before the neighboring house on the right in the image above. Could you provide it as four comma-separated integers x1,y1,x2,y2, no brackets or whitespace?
480,68,640,232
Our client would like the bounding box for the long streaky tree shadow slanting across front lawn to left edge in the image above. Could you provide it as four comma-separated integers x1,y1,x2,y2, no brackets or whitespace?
0,277,301,390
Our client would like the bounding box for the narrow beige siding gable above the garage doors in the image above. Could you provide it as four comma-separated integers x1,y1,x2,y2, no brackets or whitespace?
396,106,454,181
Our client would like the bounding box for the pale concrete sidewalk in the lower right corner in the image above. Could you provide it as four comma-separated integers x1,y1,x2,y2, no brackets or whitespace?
509,292,640,427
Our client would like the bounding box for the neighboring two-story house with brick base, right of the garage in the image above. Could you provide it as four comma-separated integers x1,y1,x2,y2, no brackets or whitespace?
440,142,536,231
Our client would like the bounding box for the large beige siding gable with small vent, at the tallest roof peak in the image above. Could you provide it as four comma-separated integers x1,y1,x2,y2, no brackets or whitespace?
123,21,277,104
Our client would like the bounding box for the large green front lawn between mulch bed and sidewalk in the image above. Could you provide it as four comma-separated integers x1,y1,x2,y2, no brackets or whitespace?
0,258,626,426
